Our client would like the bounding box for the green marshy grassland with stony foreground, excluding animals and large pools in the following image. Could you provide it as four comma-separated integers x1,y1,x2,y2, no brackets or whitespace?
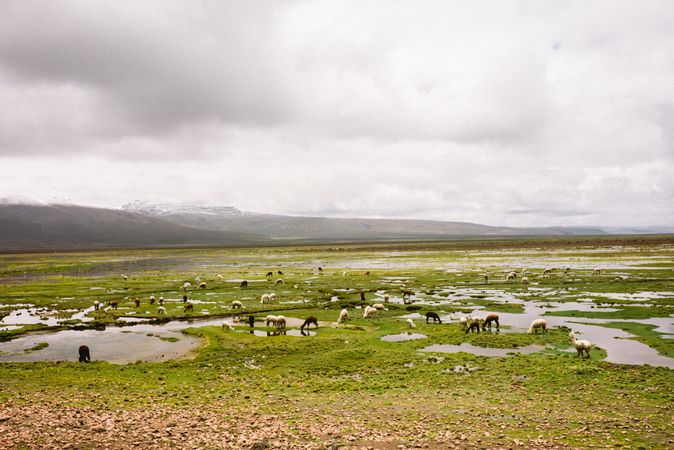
0,237,674,449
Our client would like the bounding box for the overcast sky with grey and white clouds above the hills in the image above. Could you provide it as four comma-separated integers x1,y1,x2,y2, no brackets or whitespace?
0,0,674,226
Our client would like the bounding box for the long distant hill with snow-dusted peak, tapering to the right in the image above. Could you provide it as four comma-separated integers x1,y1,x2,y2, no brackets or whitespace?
122,202,606,241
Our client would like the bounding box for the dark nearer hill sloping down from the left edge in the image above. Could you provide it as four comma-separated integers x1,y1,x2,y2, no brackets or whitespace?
0,203,266,251
